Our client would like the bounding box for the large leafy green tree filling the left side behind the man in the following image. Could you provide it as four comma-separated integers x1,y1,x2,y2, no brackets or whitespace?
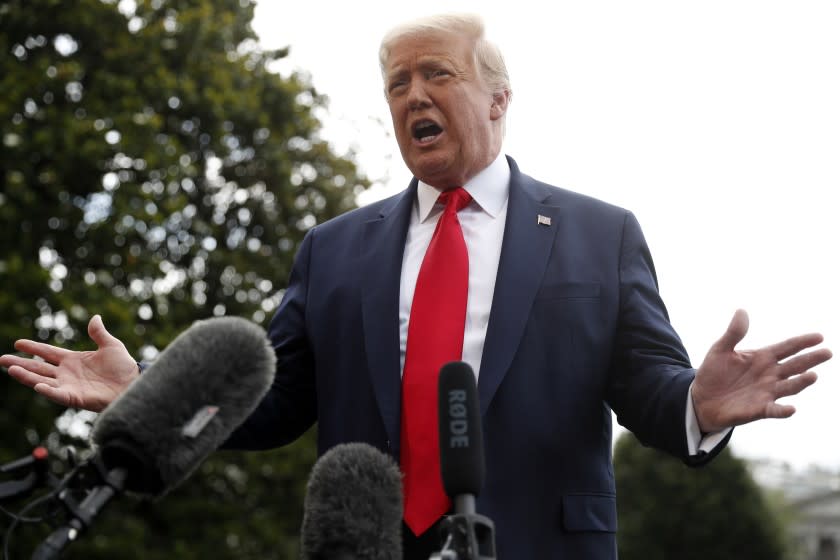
0,0,368,559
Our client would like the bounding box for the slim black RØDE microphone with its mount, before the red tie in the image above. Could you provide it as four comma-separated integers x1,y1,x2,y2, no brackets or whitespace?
432,362,496,560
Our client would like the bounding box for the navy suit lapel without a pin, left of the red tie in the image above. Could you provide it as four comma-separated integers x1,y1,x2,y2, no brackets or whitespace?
360,184,417,446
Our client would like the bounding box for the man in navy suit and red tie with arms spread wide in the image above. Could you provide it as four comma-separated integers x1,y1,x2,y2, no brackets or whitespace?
0,16,831,560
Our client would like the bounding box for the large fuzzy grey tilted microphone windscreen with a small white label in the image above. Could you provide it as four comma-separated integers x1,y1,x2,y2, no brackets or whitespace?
91,317,276,496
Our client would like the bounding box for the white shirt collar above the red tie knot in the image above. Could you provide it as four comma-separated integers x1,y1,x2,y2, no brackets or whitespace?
417,151,510,222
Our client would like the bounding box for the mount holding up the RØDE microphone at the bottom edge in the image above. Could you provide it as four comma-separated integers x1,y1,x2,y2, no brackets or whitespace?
429,494,496,560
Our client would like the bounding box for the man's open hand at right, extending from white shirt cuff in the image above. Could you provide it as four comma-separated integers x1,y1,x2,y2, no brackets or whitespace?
691,309,831,433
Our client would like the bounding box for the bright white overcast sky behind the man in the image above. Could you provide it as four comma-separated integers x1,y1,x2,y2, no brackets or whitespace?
254,0,840,469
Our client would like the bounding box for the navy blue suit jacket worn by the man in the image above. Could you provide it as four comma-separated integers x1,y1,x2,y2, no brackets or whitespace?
229,158,724,560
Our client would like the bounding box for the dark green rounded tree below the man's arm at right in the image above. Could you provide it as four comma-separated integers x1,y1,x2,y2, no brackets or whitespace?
614,433,788,560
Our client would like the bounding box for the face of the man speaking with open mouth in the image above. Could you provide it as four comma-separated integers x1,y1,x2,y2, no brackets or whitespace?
385,32,508,190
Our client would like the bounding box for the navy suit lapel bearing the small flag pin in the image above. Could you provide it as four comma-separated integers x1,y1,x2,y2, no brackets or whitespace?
478,158,560,415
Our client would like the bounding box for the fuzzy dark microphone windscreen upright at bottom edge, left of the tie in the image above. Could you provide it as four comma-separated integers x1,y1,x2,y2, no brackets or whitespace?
301,443,402,560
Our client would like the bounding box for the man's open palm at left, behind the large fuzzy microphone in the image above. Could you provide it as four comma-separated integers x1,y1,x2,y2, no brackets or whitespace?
0,315,139,412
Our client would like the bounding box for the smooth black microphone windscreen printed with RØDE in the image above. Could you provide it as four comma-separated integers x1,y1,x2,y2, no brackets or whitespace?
438,362,484,498
